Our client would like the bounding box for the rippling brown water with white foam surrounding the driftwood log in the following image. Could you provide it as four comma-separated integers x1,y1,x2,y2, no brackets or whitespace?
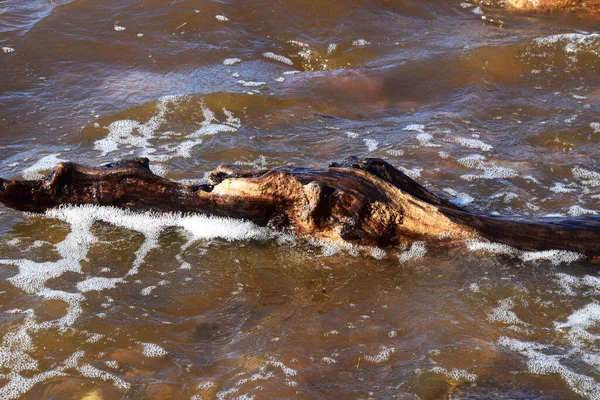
0,0,600,400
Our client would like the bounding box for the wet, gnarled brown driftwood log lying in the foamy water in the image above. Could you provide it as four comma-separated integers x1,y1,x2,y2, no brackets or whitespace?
0,158,600,256
